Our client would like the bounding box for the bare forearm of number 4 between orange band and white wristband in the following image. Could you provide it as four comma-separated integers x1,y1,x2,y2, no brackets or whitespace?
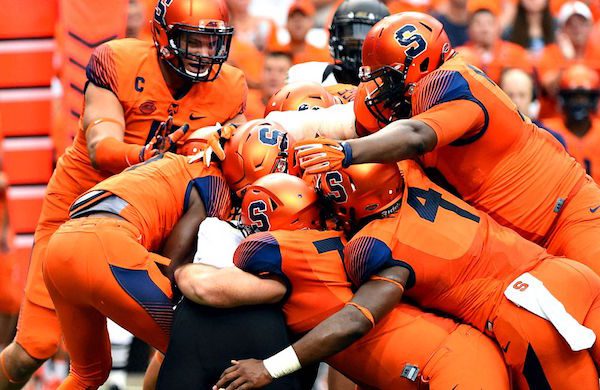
293,306,372,367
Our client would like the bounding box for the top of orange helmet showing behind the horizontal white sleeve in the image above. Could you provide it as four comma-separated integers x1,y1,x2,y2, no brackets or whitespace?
265,81,336,116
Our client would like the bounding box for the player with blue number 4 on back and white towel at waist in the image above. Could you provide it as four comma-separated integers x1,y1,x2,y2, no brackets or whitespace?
226,161,600,389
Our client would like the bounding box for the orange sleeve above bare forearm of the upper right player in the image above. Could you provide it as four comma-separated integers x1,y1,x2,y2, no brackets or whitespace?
411,100,486,147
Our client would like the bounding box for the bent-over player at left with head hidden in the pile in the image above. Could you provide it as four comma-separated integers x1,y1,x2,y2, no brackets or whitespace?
43,153,231,389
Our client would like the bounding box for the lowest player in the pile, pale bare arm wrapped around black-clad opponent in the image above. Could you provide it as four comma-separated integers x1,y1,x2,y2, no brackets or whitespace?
176,173,508,390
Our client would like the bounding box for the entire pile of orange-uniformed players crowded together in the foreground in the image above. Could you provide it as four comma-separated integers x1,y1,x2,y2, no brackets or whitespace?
0,0,600,390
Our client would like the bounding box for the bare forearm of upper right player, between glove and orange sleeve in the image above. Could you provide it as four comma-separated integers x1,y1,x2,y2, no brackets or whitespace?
346,120,436,164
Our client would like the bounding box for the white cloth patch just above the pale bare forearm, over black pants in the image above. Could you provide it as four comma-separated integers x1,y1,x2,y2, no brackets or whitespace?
194,217,244,268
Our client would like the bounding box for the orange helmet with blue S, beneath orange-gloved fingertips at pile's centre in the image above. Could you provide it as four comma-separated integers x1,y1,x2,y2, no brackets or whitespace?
221,119,299,197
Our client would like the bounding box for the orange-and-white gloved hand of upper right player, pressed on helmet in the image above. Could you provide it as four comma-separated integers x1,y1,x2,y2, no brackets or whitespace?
294,138,352,174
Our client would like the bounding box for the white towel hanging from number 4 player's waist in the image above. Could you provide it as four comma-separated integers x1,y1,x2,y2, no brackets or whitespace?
504,272,596,351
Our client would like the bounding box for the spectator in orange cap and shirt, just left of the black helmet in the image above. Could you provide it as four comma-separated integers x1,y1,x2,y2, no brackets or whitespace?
269,0,333,64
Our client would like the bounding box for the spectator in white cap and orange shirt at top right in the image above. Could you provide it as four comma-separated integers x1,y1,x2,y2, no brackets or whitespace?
537,1,600,118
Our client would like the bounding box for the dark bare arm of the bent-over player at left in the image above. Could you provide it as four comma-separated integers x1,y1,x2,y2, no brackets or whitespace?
162,185,206,280
